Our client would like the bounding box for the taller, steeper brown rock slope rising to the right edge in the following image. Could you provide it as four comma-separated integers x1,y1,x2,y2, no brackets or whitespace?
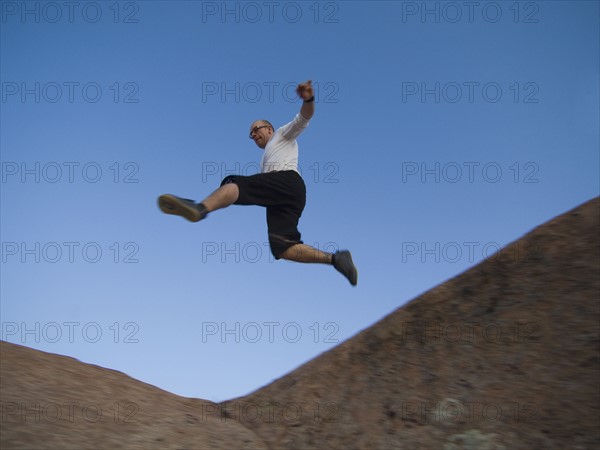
221,198,600,450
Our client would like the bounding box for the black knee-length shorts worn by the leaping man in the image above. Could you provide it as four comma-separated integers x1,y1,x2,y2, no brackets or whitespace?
221,170,306,259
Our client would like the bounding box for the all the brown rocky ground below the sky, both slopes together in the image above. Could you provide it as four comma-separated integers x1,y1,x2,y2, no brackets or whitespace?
0,198,600,450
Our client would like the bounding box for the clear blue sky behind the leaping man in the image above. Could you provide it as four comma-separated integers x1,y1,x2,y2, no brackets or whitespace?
0,1,600,401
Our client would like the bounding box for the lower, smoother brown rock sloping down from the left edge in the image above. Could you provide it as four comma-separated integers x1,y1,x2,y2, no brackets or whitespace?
0,342,268,450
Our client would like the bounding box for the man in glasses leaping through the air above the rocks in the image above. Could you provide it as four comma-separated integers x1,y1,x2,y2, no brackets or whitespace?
158,80,358,286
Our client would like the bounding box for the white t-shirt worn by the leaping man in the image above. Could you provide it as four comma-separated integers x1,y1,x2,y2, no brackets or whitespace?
260,113,309,173
